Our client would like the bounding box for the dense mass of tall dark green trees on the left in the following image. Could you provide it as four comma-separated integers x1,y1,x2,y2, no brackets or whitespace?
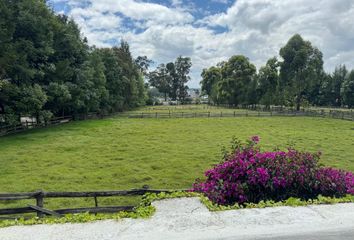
0,0,149,124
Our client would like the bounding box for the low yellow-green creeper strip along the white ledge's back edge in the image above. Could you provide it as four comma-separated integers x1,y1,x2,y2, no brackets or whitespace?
0,191,354,227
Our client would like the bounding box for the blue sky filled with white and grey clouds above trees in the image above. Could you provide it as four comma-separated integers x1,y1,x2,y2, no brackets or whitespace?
48,0,354,87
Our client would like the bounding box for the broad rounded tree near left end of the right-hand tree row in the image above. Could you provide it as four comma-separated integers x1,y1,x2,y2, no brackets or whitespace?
217,55,256,105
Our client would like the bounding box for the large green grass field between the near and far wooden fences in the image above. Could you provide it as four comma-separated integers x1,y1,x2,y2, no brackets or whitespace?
0,117,354,208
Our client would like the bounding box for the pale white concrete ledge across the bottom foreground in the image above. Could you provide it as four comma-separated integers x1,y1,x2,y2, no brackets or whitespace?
0,198,354,240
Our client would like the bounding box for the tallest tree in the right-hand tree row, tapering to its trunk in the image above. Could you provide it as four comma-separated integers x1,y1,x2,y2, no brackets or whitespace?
279,34,323,110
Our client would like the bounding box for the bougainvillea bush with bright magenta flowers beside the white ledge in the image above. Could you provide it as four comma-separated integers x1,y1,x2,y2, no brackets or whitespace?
193,136,354,205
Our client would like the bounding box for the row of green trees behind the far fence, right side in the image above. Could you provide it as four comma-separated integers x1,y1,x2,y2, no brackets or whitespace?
201,34,354,110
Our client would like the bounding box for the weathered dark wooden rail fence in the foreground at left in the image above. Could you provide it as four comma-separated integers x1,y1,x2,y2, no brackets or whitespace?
0,188,176,219
